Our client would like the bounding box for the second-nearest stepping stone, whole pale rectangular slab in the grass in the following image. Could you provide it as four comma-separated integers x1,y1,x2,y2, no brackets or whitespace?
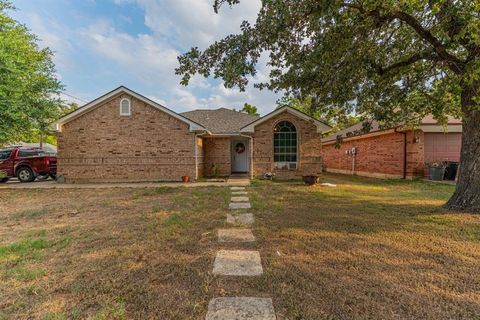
213,250,263,276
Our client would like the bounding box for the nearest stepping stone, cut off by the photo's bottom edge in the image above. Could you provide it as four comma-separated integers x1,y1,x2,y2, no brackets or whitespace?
205,297,277,320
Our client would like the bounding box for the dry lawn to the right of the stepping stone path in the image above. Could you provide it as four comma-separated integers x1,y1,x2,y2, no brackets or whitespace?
250,175,480,320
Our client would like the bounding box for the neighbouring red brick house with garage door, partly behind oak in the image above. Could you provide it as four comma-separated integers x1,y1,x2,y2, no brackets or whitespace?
322,116,462,179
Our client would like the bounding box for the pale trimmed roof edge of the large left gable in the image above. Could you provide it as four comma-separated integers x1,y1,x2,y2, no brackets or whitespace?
54,86,206,131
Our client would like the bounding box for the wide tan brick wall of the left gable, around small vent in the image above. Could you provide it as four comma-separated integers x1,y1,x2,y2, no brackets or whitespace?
58,94,196,182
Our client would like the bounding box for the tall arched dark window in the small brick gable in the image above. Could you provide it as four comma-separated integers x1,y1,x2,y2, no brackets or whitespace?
273,121,297,169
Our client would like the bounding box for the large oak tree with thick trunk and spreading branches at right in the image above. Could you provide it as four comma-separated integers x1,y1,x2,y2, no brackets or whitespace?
177,0,480,211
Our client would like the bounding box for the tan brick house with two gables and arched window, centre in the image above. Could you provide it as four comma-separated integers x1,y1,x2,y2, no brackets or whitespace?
55,86,330,182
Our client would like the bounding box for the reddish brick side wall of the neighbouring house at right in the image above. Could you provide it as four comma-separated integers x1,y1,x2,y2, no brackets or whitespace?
323,131,424,178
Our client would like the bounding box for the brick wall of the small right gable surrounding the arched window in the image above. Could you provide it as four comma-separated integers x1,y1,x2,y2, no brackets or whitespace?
252,111,322,178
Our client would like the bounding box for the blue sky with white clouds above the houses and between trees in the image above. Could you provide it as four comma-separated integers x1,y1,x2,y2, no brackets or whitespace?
10,0,280,114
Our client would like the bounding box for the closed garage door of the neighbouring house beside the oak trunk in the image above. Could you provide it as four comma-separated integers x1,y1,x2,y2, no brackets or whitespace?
425,133,462,163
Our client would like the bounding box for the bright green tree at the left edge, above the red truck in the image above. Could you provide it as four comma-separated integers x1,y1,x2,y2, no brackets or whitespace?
0,0,62,143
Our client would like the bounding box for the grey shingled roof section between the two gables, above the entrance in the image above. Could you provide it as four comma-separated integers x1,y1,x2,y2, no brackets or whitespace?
181,108,259,134
